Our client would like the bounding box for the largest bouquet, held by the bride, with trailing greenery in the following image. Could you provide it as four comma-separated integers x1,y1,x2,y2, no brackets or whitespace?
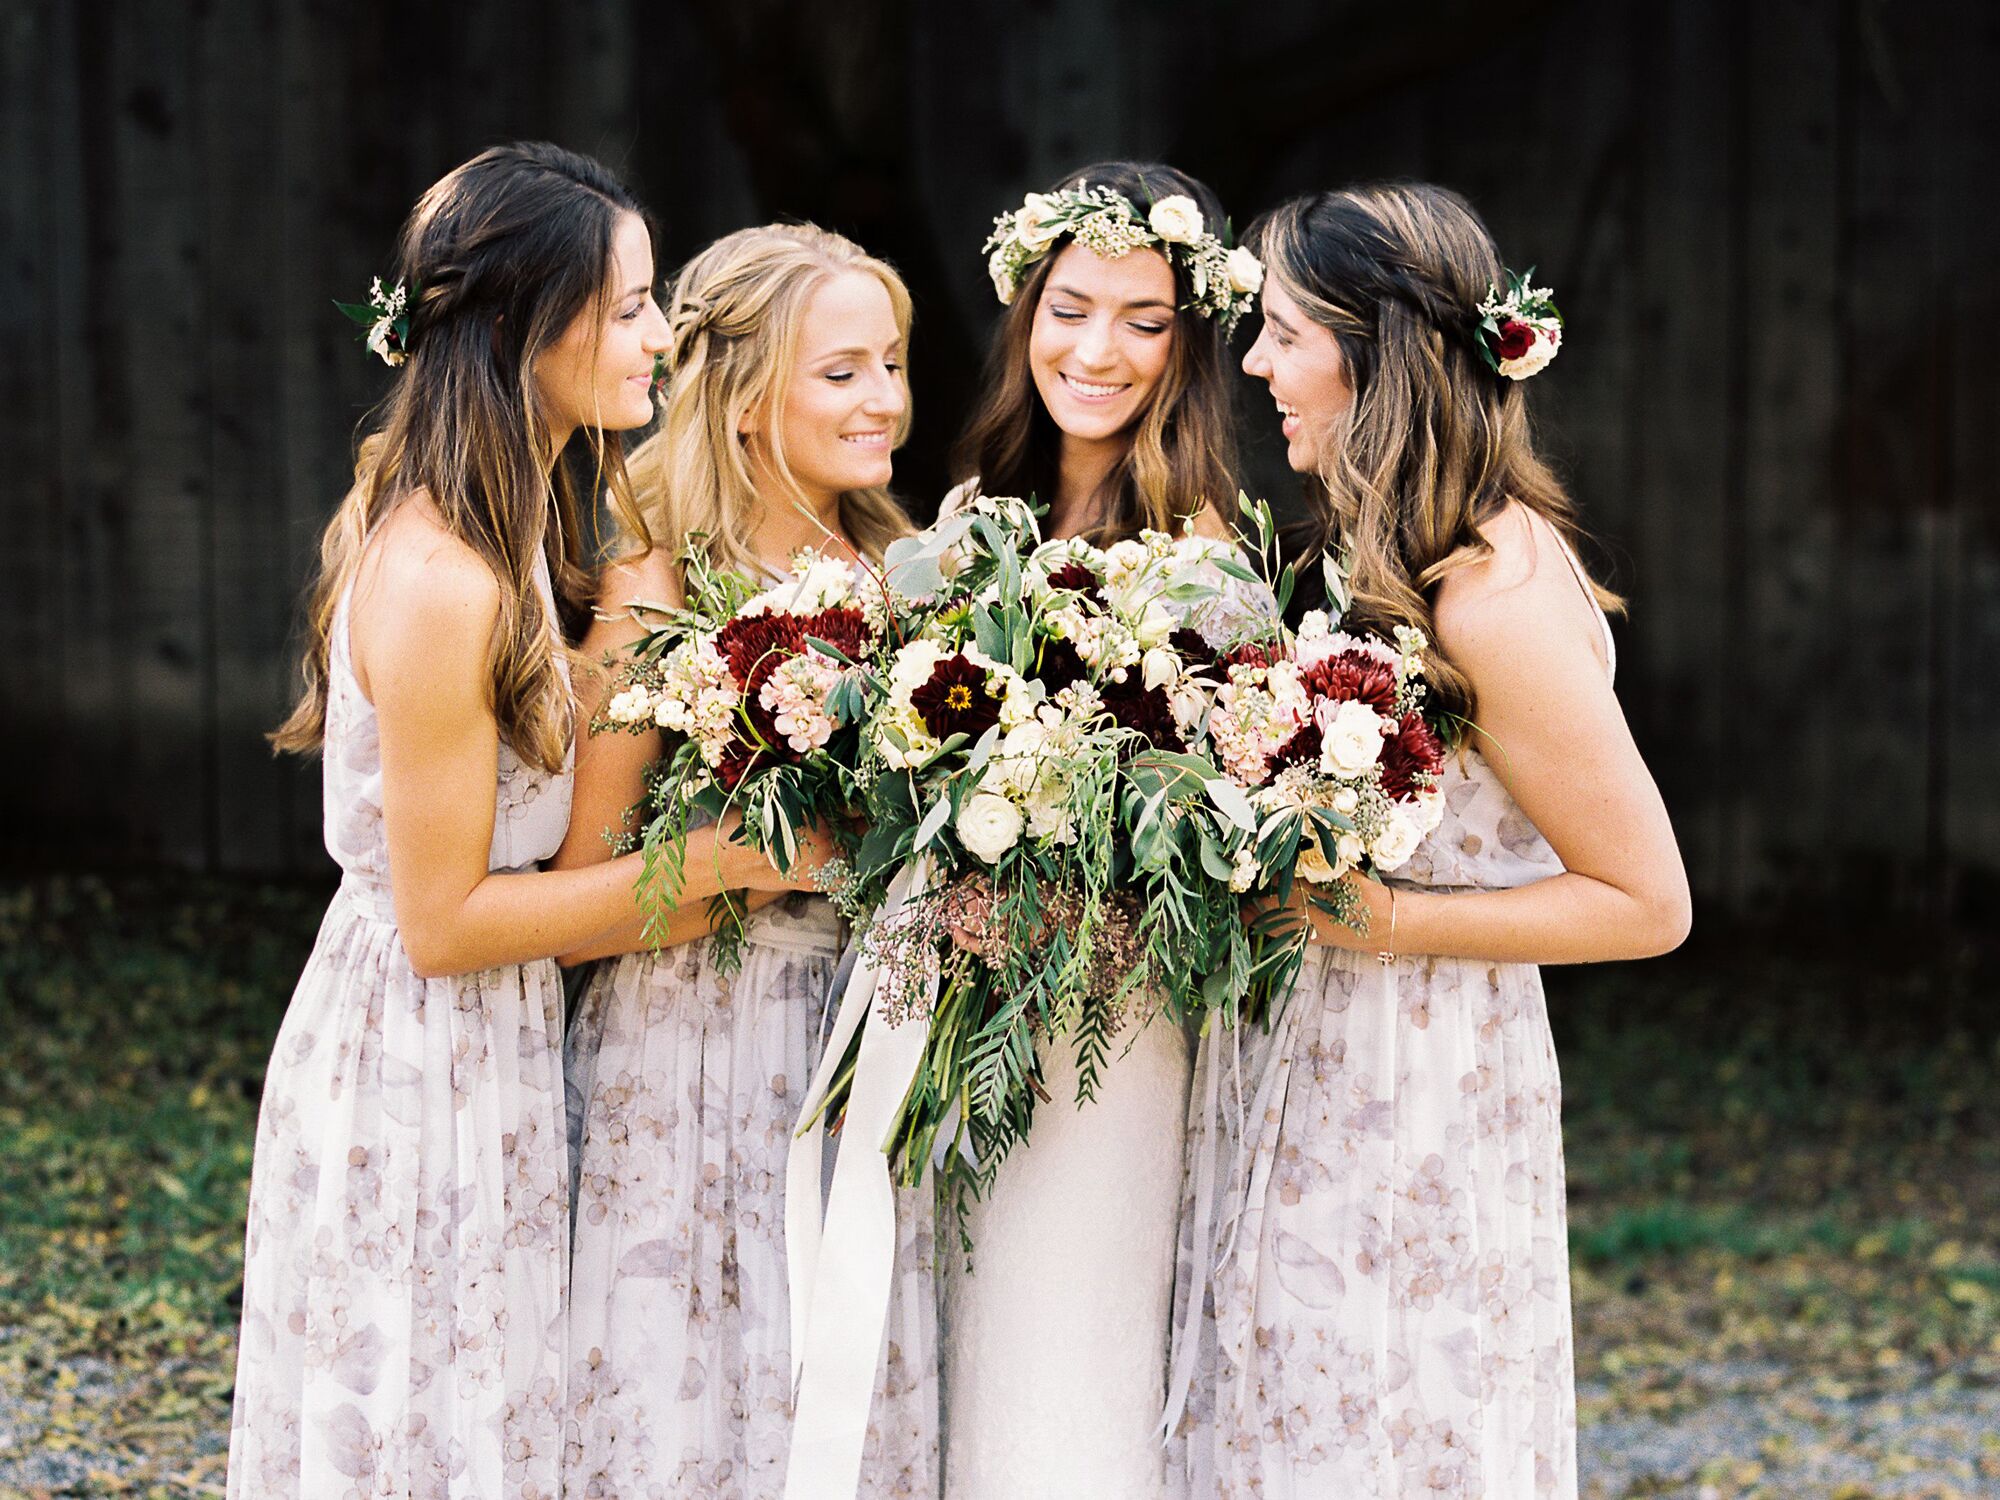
808,496,1272,1184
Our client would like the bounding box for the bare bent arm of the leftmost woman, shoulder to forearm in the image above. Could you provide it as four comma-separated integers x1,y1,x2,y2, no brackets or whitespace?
352,514,638,976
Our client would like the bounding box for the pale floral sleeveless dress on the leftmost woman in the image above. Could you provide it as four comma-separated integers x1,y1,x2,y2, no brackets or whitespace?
228,564,570,1500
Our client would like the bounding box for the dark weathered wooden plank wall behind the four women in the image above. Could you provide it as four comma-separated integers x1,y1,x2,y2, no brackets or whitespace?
0,0,2000,920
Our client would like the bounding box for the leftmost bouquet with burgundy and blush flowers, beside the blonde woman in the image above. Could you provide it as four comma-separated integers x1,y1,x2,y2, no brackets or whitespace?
592,548,884,964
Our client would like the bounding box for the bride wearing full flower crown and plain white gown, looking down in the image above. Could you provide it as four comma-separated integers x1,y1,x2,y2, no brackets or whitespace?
944,162,1270,1500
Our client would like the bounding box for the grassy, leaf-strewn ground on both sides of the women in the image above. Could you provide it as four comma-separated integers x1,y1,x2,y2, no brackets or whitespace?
0,880,2000,1500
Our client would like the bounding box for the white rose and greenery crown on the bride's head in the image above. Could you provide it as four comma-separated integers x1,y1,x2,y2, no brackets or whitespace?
982,184,1264,338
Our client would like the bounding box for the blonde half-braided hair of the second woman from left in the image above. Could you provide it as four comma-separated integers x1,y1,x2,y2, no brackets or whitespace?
630,224,912,576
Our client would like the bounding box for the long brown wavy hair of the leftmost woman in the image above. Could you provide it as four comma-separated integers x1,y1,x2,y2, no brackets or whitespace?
270,142,644,770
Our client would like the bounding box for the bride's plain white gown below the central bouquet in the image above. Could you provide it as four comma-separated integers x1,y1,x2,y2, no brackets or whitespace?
938,486,1264,1500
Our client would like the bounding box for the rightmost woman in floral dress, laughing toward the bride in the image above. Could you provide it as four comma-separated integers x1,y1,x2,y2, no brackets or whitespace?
1168,184,1688,1500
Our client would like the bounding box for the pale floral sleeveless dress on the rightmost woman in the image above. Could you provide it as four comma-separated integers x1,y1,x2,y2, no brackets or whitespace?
1172,532,1612,1500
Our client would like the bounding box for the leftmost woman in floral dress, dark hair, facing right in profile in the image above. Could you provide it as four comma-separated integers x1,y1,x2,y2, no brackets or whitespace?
228,144,666,1500
